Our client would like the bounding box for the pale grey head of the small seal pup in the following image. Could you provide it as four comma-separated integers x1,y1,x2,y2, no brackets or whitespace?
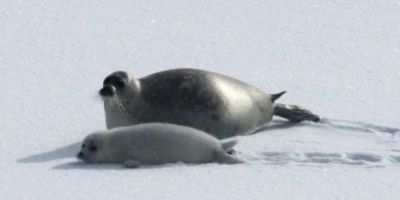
77,133,112,163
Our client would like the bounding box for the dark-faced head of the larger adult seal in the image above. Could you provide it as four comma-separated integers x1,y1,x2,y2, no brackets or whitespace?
99,71,140,111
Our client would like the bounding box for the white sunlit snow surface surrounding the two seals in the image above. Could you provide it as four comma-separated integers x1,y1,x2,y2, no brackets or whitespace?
0,0,400,200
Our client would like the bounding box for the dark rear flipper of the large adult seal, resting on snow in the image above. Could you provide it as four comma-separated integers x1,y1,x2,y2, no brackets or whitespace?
274,103,320,123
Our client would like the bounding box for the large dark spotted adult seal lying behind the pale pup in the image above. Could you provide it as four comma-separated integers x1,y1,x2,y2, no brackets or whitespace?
99,69,319,138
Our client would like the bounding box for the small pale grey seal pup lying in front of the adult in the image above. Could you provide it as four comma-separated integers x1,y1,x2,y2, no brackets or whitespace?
77,123,243,168
